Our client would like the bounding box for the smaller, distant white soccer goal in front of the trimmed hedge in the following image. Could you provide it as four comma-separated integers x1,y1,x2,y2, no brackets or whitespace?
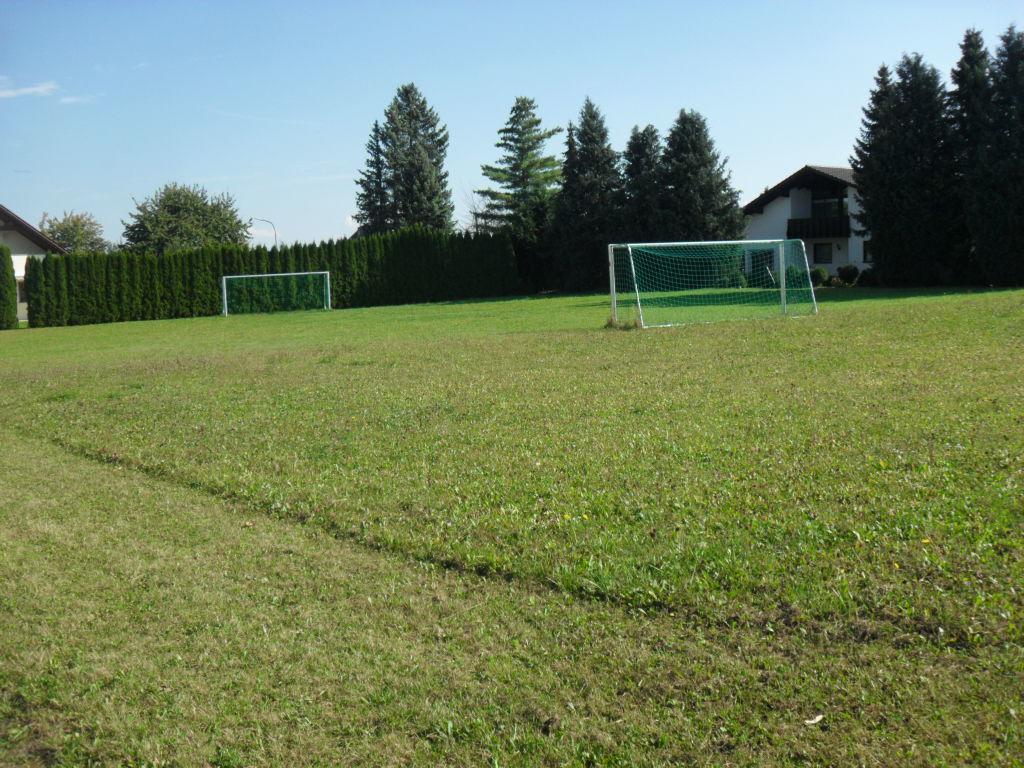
220,272,331,316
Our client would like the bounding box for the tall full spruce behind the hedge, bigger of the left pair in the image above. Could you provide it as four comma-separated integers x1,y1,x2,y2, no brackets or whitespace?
381,83,455,230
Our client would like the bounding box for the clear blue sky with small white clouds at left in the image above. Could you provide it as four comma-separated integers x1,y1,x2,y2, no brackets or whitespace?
0,0,1024,242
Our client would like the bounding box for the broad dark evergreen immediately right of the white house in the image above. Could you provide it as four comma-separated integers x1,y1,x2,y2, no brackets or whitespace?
851,54,959,285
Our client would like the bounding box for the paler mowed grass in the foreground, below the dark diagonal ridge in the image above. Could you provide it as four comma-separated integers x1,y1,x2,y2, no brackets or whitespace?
0,439,1021,766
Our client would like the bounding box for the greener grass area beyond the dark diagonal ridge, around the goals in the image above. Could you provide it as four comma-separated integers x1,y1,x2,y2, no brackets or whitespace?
4,291,1024,648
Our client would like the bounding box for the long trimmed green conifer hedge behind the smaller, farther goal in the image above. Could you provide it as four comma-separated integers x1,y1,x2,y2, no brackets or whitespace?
26,227,520,328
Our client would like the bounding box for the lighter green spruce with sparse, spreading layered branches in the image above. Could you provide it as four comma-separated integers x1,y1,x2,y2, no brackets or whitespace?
475,96,561,290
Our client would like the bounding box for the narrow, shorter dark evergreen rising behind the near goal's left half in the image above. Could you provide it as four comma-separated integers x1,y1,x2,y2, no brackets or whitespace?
622,125,664,243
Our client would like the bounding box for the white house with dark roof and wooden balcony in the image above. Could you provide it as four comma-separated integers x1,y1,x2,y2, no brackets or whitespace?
743,165,871,274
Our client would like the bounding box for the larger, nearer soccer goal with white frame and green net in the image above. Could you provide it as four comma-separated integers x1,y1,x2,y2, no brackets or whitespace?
608,240,818,328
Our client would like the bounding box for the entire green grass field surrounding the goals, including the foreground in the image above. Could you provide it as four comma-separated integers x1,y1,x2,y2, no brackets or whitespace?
0,289,1024,767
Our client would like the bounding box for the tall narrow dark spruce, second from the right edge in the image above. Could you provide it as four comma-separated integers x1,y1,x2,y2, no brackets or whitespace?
949,30,992,283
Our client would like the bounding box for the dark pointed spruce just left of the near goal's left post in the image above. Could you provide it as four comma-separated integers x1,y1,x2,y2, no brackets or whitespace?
553,98,623,291
